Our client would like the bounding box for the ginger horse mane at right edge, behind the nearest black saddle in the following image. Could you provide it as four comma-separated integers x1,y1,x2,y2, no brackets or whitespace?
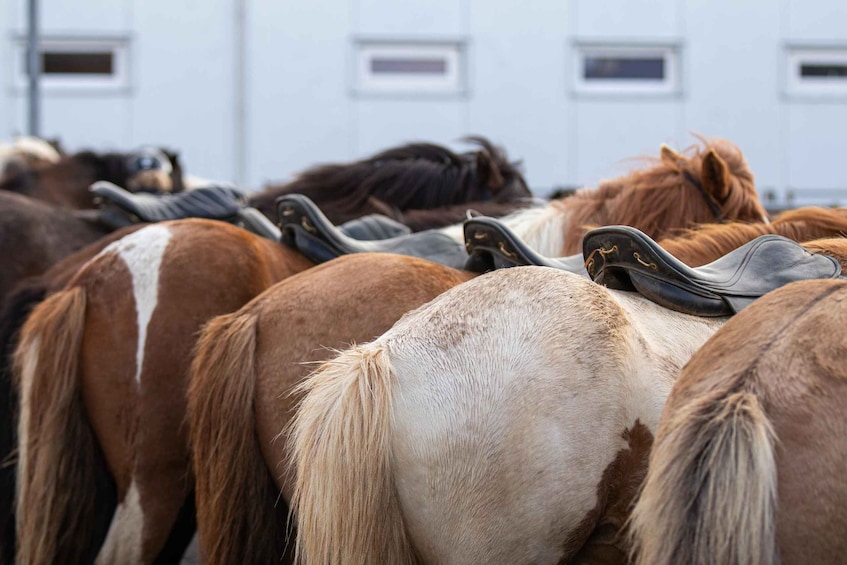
659,206,847,267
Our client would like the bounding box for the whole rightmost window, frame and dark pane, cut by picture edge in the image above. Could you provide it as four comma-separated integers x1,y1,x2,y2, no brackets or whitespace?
786,47,847,97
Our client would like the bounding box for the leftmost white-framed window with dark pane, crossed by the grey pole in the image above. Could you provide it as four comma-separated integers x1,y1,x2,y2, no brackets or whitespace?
14,38,128,89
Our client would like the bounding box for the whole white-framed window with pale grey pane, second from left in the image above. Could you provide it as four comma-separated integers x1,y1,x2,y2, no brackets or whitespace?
354,41,464,94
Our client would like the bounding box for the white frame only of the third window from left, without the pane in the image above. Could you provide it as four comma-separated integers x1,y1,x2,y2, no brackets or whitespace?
571,42,681,96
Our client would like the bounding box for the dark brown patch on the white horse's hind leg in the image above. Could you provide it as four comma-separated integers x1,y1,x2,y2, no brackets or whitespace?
559,420,653,565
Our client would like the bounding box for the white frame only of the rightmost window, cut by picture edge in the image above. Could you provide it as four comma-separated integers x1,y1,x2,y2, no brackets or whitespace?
785,45,847,99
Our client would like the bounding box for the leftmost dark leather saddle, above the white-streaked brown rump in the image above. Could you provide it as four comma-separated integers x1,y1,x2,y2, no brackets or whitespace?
91,181,244,226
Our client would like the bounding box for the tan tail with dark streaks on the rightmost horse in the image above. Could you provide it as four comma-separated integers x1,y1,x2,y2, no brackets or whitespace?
630,390,779,565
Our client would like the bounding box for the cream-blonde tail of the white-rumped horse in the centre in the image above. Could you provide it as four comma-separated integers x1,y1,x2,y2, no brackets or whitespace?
290,344,415,564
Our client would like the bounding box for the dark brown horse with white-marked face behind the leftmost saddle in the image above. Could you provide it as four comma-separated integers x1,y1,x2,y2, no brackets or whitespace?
0,147,184,210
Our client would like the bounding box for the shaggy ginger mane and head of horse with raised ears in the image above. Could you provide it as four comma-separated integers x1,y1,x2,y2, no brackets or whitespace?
557,137,764,247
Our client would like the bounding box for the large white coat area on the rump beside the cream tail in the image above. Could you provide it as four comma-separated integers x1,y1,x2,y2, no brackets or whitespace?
380,267,724,563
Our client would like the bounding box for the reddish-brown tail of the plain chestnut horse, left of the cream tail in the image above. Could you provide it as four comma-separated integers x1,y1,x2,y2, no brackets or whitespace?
188,312,287,565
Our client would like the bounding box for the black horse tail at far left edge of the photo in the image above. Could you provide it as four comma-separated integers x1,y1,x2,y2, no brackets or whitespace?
0,278,47,564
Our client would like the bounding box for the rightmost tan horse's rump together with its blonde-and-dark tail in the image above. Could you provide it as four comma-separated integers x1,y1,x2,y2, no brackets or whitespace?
630,270,847,565
